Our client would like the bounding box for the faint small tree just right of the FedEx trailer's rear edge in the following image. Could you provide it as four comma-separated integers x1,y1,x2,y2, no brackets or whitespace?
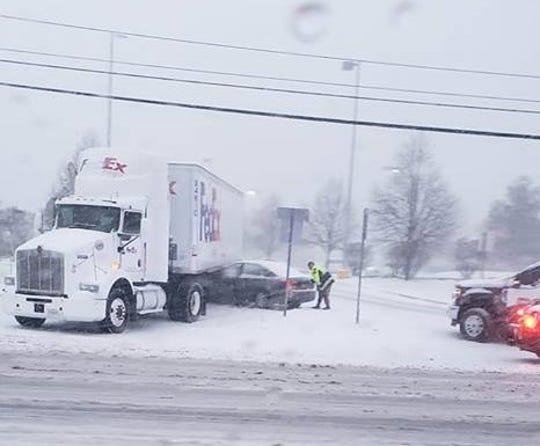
247,195,280,258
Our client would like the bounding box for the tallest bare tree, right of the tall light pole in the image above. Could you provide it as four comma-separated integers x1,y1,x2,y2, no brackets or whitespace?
373,135,457,280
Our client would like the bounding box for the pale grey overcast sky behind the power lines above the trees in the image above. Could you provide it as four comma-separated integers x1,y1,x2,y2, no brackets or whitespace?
0,0,540,234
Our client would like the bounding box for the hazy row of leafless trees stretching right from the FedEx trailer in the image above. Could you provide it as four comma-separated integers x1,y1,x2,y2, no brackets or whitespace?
247,134,540,280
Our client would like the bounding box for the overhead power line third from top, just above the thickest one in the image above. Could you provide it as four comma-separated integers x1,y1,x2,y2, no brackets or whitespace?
4,59,540,114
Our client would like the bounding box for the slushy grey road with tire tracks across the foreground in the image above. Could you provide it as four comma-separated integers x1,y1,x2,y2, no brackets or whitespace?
0,352,540,446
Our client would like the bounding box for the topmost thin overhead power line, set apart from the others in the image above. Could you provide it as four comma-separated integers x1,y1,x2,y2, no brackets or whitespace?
0,14,540,79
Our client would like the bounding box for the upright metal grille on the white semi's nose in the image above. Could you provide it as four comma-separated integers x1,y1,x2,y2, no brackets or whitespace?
17,248,64,295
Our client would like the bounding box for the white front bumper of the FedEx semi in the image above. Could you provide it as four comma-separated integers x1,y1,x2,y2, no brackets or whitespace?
0,290,107,322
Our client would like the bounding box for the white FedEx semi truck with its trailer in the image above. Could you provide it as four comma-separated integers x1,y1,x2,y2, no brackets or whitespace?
1,148,243,333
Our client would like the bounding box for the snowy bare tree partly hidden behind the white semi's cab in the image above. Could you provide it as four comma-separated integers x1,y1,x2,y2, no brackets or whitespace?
41,132,99,231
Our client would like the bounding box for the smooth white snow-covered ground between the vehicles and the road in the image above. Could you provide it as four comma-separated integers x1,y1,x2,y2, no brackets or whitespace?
0,264,540,372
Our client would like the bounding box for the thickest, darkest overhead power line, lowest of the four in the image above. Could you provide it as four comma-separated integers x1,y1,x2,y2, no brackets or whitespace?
0,81,540,140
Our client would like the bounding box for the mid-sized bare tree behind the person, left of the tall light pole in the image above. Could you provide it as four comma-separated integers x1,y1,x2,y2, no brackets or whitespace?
306,180,356,268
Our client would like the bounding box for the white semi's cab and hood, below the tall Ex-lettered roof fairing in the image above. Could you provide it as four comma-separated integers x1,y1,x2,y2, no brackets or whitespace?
4,196,155,327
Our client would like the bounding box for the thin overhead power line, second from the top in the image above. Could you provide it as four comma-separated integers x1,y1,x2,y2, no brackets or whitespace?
0,48,540,104
